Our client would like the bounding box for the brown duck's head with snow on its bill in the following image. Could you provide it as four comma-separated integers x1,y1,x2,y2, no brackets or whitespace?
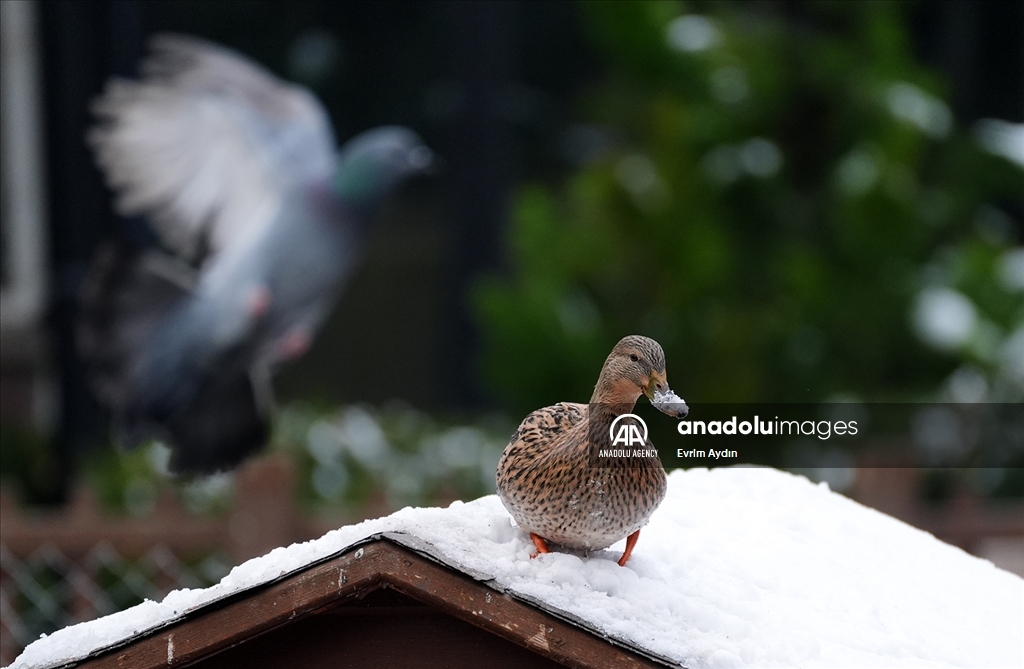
594,335,689,418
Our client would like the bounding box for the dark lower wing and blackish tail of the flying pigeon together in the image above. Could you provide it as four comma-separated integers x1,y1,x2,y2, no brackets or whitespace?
77,243,269,473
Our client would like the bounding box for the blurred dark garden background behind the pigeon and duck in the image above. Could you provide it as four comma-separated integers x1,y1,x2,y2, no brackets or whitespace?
0,0,1024,663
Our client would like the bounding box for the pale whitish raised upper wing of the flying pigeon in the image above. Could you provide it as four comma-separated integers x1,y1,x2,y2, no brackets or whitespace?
89,35,334,259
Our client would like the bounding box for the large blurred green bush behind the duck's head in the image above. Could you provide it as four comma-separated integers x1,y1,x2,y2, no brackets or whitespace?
475,2,1024,412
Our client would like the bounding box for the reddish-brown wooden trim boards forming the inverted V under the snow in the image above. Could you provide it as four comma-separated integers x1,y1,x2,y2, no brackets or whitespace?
80,541,662,669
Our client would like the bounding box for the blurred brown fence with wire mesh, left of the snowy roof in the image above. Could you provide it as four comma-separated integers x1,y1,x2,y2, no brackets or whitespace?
0,457,340,666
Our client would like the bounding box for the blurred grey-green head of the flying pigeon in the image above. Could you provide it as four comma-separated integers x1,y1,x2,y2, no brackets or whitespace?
334,126,435,208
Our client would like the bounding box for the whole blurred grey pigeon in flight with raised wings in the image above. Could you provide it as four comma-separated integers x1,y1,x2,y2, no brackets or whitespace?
78,35,433,473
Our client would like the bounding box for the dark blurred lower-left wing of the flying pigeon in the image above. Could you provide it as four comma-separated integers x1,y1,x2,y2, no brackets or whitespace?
77,242,195,414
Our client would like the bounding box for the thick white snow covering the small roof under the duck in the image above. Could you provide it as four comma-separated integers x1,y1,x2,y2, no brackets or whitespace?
11,468,1024,669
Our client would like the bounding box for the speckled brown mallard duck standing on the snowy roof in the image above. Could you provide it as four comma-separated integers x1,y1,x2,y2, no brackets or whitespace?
497,335,688,566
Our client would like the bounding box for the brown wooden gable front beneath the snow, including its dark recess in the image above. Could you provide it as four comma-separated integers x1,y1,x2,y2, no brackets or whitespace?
71,533,672,669
